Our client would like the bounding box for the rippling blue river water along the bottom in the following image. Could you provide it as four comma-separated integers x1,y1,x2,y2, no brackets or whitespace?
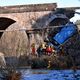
21,69,80,80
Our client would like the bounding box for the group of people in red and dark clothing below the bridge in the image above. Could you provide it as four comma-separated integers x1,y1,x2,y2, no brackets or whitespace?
31,42,55,57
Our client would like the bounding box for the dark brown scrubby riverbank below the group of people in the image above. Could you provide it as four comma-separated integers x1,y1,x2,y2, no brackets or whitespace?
18,54,80,69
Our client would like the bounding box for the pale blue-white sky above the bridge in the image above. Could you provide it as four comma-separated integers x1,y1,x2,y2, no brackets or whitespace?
0,0,80,22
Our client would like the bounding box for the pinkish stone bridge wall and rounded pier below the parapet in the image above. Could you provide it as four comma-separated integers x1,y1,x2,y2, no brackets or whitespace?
0,11,51,55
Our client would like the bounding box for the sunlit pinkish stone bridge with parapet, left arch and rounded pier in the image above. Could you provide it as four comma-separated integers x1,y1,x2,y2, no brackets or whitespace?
0,3,57,55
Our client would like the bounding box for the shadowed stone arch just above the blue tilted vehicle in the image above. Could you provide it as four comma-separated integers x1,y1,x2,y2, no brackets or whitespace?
46,14,69,26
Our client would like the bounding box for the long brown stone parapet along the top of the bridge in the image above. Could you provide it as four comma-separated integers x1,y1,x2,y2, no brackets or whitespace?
0,3,57,13
